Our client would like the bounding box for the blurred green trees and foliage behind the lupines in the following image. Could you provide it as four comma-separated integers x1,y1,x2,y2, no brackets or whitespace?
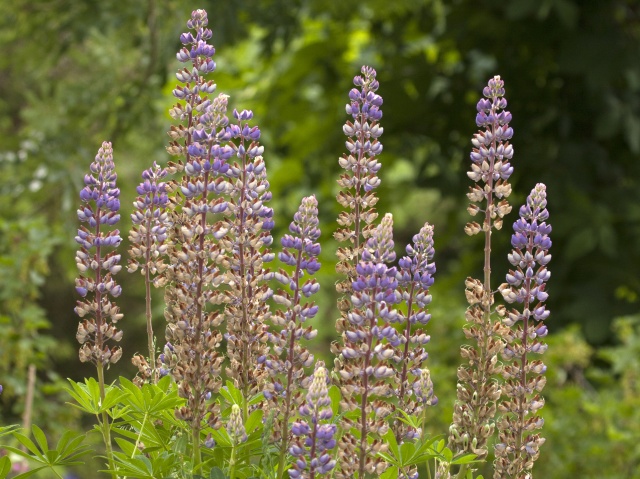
0,0,640,479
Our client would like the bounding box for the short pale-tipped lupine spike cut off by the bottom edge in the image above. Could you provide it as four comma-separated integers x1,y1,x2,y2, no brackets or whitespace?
288,361,337,479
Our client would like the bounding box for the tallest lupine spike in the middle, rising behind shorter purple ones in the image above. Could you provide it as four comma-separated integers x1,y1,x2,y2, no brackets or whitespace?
334,66,383,308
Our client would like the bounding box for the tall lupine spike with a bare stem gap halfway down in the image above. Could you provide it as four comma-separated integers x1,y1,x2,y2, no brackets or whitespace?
449,76,513,459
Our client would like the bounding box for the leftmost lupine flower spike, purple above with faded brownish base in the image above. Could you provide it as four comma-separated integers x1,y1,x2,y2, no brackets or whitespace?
75,142,122,368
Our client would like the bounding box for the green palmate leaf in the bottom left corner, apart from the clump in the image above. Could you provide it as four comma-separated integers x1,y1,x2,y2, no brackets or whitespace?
0,425,91,479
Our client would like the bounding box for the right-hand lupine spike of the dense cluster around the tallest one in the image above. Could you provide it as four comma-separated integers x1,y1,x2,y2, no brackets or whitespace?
219,110,274,414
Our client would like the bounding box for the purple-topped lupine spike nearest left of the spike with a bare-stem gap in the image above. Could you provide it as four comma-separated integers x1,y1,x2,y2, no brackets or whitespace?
394,223,438,442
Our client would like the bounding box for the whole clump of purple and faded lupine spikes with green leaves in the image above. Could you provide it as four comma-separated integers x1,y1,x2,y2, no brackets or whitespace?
0,10,551,479
